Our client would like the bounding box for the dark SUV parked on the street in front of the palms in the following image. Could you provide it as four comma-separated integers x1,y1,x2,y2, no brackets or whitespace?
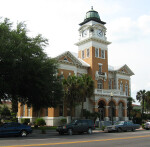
56,119,95,135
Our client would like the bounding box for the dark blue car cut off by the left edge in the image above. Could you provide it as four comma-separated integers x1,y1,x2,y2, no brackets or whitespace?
0,122,32,137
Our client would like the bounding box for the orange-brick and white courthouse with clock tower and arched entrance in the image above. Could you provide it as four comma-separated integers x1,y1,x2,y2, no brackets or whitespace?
18,8,134,126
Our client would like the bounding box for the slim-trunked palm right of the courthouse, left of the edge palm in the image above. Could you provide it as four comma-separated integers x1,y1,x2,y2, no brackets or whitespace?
136,90,147,119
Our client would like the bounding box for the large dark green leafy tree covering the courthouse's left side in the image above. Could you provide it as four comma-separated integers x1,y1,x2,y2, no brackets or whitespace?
0,19,63,111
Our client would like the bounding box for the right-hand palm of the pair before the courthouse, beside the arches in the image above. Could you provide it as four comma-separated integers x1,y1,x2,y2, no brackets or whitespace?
78,75,94,117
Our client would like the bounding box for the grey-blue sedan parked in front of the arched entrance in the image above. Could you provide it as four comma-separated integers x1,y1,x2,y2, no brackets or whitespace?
104,121,140,132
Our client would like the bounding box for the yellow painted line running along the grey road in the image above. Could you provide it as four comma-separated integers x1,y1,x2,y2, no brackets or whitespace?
0,135,150,147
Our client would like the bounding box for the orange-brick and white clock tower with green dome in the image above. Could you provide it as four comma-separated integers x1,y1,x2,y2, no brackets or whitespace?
76,7,111,89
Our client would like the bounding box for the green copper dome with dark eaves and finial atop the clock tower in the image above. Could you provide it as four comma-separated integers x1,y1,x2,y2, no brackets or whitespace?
79,7,106,25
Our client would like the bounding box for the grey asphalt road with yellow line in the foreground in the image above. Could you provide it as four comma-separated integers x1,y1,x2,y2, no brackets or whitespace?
0,130,150,147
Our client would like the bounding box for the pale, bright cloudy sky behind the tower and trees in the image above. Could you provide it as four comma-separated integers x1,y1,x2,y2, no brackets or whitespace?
0,0,150,103
